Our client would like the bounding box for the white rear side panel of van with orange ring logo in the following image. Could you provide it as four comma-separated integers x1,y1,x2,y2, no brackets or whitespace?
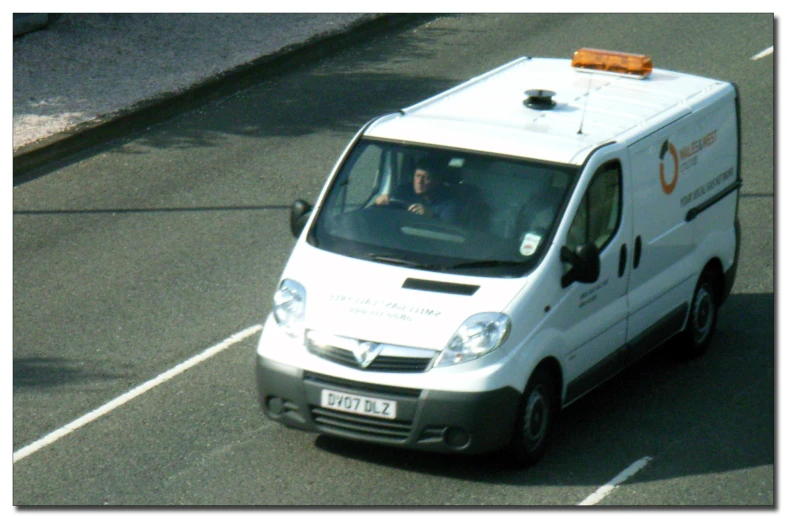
627,87,738,348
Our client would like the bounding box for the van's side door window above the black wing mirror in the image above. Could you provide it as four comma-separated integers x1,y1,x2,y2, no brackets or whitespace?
566,161,622,250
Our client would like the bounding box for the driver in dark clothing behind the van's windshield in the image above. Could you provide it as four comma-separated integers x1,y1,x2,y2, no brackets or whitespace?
374,159,456,222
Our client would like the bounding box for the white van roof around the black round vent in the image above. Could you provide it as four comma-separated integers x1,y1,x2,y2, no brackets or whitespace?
365,58,728,165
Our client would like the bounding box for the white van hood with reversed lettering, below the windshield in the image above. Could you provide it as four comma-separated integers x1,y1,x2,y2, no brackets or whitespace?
282,243,527,350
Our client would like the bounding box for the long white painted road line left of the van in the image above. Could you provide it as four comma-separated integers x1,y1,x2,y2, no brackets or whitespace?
14,324,262,463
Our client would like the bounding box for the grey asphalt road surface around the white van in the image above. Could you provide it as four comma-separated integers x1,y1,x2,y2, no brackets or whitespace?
13,14,775,507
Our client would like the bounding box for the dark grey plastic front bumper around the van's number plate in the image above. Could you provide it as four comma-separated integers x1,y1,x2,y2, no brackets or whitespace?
256,355,520,454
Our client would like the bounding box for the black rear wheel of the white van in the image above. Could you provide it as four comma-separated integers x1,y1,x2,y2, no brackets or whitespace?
675,273,719,360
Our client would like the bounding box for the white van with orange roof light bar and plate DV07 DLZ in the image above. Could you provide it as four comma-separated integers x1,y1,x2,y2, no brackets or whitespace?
256,49,740,466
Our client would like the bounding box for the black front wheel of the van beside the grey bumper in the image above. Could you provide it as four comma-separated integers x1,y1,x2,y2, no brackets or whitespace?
504,369,560,468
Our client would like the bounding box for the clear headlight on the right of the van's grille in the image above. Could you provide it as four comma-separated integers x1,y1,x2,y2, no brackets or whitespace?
434,312,511,368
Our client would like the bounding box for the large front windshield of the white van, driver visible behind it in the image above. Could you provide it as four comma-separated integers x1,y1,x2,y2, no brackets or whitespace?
308,139,578,277
